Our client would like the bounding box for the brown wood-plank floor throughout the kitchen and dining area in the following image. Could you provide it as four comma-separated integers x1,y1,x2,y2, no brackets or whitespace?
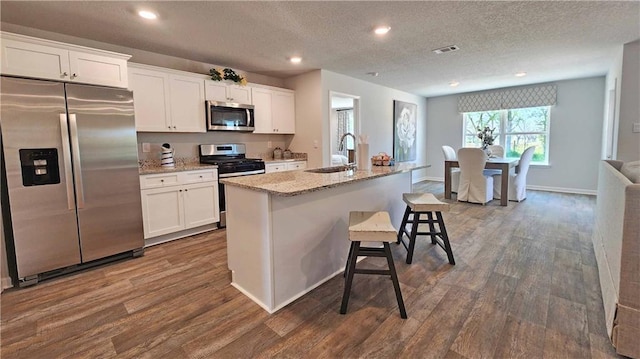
0,182,618,359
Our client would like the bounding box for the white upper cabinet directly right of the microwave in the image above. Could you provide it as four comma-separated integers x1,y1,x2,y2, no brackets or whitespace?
251,87,296,134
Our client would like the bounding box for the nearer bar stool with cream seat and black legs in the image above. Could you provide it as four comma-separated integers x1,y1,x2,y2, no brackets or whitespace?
340,212,407,319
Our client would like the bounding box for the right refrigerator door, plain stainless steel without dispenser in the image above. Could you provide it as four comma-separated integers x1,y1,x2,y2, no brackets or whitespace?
66,84,144,262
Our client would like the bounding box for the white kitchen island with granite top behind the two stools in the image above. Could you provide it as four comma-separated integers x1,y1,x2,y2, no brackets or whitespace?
221,163,428,313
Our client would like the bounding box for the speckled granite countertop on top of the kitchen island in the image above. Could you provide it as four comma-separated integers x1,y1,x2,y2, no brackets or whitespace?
220,163,431,196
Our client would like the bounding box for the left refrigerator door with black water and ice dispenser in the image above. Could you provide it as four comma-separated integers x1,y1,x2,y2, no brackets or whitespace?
0,77,80,278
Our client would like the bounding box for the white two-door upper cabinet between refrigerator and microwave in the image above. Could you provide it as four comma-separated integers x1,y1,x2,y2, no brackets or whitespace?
129,64,207,132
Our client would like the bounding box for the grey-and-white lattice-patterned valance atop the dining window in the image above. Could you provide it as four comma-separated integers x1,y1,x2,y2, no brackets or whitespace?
458,84,557,112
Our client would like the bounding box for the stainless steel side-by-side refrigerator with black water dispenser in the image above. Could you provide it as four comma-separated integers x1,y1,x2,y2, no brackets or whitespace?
0,76,144,286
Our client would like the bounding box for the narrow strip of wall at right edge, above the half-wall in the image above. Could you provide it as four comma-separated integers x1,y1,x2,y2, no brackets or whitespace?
617,40,640,161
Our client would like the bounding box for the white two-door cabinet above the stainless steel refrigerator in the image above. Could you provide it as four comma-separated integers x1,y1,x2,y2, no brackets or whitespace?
0,32,131,88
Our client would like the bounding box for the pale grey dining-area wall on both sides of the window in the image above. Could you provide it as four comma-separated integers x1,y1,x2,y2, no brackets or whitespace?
426,76,605,194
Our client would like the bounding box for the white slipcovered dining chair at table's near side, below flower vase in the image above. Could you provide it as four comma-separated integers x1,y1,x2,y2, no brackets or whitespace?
458,148,493,204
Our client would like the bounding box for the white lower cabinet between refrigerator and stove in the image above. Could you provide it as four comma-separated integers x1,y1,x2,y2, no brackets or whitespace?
140,169,220,239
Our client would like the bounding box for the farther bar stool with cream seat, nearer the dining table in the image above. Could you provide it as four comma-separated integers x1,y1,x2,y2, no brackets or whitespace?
397,193,456,265
